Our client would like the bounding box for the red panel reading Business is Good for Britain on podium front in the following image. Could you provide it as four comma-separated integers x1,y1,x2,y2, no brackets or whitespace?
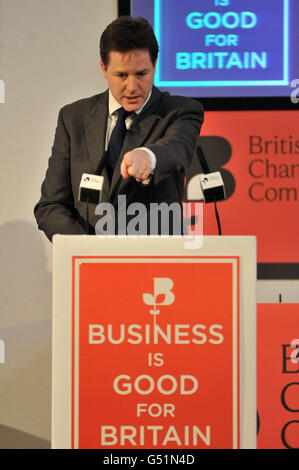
73,257,239,449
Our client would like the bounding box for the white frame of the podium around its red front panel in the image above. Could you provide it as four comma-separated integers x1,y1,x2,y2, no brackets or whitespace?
52,235,256,449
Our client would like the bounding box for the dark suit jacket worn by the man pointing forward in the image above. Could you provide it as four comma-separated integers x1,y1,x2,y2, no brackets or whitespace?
34,87,203,240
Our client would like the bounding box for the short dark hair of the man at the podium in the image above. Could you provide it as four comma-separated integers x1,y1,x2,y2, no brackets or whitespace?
100,16,159,67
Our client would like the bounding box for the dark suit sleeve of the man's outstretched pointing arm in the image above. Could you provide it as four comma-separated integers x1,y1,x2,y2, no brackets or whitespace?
146,98,204,184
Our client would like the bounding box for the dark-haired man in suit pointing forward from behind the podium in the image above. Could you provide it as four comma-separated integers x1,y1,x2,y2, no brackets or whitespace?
34,17,203,240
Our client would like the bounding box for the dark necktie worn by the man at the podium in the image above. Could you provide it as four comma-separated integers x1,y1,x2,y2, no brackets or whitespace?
107,108,130,178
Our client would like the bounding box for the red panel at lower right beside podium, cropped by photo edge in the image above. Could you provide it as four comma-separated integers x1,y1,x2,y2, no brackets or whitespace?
257,304,299,449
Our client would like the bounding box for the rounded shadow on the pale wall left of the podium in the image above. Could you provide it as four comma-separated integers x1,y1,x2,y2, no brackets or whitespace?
0,221,52,449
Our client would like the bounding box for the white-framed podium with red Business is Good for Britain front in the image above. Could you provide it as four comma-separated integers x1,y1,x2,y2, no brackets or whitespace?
52,235,256,450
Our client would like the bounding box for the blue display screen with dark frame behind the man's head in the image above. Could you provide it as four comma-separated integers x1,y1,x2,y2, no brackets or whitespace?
131,0,299,97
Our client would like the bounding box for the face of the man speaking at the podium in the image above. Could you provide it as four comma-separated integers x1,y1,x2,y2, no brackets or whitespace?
100,49,156,111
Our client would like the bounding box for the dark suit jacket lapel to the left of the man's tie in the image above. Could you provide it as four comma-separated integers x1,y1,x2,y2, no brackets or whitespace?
84,91,108,173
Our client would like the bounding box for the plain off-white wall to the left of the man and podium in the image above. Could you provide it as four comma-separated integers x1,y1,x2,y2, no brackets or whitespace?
0,0,117,448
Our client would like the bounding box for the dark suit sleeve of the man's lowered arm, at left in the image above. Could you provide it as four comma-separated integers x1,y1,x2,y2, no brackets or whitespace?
34,109,85,241
